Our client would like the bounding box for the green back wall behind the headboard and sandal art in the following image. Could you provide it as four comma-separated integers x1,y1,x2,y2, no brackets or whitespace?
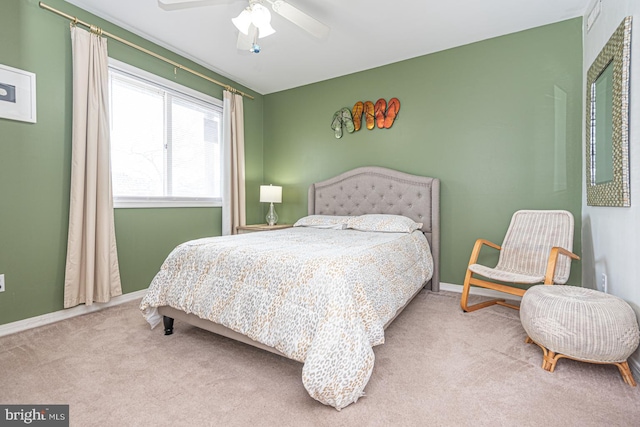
264,18,582,290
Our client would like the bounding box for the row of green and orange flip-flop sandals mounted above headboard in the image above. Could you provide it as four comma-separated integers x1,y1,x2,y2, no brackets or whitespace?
331,98,400,138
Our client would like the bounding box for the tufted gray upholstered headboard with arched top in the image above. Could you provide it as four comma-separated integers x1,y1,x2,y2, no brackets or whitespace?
308,166,440,291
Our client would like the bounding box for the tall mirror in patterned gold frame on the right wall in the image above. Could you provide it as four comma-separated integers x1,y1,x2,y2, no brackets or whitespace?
586,16,631,206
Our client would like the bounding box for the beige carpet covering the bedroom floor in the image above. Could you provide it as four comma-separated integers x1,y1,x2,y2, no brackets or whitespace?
0,292,640,426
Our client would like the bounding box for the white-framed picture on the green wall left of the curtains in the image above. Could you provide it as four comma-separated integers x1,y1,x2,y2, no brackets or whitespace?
0,64,36,123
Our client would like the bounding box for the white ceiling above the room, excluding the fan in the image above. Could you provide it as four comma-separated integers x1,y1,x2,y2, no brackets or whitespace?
63,0,592,94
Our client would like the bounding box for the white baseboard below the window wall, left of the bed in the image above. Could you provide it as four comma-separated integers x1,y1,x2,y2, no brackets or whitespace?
0,289,147,337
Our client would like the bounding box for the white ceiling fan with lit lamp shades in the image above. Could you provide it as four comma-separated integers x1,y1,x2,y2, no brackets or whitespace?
158,0,329,53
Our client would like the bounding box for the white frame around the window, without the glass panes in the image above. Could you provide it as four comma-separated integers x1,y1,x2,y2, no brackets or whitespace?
108,58,222,209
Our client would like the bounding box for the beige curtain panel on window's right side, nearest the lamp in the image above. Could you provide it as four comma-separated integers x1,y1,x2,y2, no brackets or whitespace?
222,90,247,235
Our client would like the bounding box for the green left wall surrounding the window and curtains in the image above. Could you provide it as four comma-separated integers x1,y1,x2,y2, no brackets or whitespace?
0,0,263,324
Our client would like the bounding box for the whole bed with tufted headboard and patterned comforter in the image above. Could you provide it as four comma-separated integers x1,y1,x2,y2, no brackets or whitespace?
140,166,440,410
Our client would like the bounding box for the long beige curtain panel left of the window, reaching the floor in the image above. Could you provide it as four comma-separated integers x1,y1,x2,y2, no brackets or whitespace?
64,26,122,308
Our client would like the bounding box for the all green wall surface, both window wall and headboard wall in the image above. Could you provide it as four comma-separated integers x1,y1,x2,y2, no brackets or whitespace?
0,0,582,324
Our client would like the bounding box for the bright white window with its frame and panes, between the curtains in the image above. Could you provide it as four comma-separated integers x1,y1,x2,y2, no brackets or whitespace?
109,59,222,208
